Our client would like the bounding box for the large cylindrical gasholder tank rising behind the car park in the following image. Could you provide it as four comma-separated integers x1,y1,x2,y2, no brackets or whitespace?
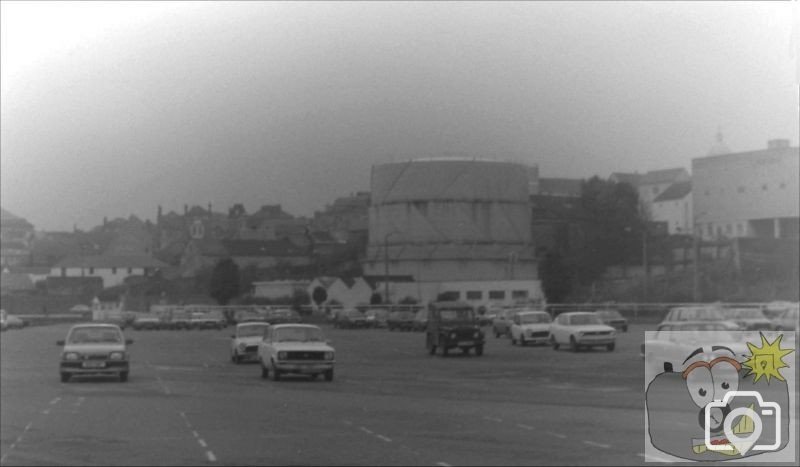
366,159,535,280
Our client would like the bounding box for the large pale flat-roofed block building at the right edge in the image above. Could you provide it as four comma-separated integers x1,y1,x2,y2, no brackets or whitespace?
692,139,800,239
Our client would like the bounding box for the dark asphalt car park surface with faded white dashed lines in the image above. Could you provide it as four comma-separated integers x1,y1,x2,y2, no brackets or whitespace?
0,325,656,466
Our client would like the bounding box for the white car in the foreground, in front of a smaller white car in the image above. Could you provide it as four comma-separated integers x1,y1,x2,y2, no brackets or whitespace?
258,324,335,381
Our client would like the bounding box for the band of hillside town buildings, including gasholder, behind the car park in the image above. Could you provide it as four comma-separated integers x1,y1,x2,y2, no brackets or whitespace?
1,134,800,313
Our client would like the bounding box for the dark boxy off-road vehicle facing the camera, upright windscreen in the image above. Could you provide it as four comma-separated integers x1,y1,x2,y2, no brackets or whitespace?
425,302,485,356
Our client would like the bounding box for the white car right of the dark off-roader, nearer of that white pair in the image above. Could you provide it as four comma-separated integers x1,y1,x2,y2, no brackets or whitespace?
550,311,617,352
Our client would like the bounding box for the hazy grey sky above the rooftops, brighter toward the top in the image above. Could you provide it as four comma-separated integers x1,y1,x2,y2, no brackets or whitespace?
0,0,800,230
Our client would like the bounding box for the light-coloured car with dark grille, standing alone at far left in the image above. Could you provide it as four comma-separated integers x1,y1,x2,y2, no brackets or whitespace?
57,323,133,383
